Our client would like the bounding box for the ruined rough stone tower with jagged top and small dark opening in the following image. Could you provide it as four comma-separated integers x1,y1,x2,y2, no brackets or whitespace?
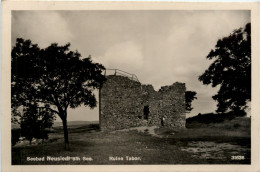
99,75,186,130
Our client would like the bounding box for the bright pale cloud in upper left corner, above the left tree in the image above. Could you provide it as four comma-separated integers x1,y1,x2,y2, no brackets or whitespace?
12,11,73,48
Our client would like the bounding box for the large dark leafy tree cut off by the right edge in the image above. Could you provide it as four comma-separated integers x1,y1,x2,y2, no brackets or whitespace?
199,23,251,114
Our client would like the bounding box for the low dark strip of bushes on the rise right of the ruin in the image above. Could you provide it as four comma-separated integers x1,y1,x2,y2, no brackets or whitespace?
186,112,245,124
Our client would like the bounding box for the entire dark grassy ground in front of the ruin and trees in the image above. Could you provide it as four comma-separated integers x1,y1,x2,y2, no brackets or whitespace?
12,118,251,165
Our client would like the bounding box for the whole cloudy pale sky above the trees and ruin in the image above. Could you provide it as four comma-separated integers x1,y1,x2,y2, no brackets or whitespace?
12,10,250,121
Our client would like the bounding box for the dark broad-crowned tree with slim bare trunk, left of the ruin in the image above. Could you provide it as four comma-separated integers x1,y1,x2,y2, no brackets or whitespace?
11,38,105,149
